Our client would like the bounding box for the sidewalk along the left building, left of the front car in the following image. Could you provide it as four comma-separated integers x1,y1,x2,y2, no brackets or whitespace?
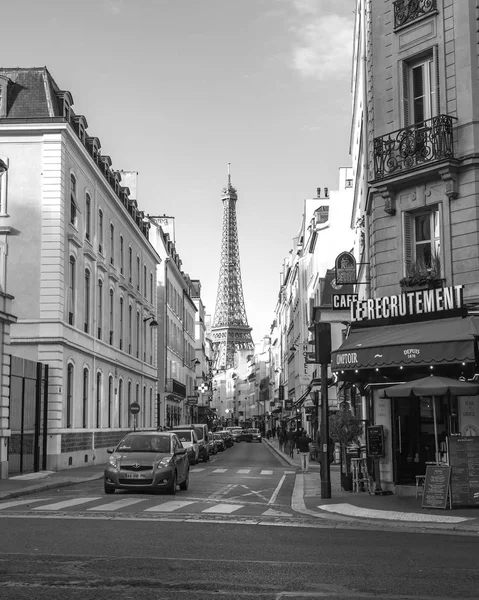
0,465,105,500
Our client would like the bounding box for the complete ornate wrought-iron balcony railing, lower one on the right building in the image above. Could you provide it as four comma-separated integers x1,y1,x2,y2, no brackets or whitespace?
374,115,454,180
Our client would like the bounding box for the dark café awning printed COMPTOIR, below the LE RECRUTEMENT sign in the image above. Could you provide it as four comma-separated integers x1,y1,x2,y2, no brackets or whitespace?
331,316,479,371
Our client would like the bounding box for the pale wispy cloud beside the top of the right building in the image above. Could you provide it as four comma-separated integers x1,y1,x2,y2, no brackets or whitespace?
291,0,353,81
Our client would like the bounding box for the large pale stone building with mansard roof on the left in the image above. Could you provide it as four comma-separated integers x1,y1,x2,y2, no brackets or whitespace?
0,68,160,470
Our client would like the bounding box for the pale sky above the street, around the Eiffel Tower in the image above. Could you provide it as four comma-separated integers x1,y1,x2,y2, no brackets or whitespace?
0,0,355,342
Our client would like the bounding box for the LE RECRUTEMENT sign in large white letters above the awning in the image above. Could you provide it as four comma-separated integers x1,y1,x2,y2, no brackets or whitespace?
351,285,464,326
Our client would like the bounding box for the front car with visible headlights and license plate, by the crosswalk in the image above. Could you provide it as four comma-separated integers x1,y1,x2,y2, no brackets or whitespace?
104,431,190,494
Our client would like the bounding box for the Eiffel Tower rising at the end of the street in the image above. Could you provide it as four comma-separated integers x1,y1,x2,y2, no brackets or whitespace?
211,163,254,370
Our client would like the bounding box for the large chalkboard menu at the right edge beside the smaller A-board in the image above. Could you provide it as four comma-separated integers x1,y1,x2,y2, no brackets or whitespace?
449,435,479,506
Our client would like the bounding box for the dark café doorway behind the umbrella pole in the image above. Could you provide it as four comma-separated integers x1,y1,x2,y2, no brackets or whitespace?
391,397,451,485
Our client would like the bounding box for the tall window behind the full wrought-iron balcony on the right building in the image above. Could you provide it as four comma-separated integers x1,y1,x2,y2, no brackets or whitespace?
402,48,439,127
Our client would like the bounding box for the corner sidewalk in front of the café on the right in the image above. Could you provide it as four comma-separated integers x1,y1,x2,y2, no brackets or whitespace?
264,438,479,533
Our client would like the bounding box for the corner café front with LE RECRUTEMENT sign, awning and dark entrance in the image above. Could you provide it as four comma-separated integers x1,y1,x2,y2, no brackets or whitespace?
332,286,479,494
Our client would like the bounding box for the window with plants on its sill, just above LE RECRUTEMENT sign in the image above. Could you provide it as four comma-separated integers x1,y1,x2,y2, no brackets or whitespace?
404,207,441,277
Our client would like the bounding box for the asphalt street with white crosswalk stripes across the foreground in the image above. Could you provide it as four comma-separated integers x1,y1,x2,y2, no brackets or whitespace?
0,443,479,600
